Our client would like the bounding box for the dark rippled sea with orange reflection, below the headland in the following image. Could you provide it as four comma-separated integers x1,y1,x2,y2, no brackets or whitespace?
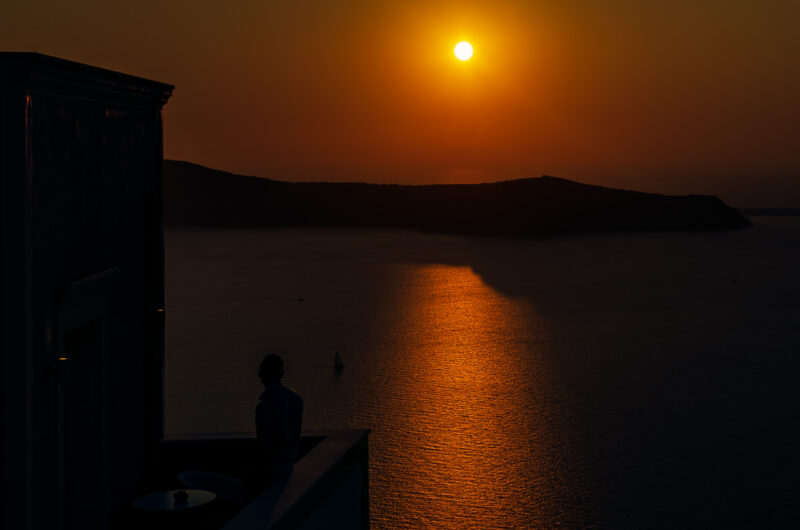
166,218,800,528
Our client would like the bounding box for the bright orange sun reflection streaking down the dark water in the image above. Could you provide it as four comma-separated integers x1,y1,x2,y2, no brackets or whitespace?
364,265,549,528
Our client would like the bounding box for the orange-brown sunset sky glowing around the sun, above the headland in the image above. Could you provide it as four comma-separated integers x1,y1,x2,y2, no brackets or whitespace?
0,0,800,206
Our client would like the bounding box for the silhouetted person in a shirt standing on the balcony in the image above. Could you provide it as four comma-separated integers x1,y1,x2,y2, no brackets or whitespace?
249,354,303,495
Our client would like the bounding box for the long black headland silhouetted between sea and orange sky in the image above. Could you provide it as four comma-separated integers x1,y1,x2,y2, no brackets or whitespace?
164,160,750,236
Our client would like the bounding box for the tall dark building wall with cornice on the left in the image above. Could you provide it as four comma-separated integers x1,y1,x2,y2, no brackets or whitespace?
0,53,173,529
